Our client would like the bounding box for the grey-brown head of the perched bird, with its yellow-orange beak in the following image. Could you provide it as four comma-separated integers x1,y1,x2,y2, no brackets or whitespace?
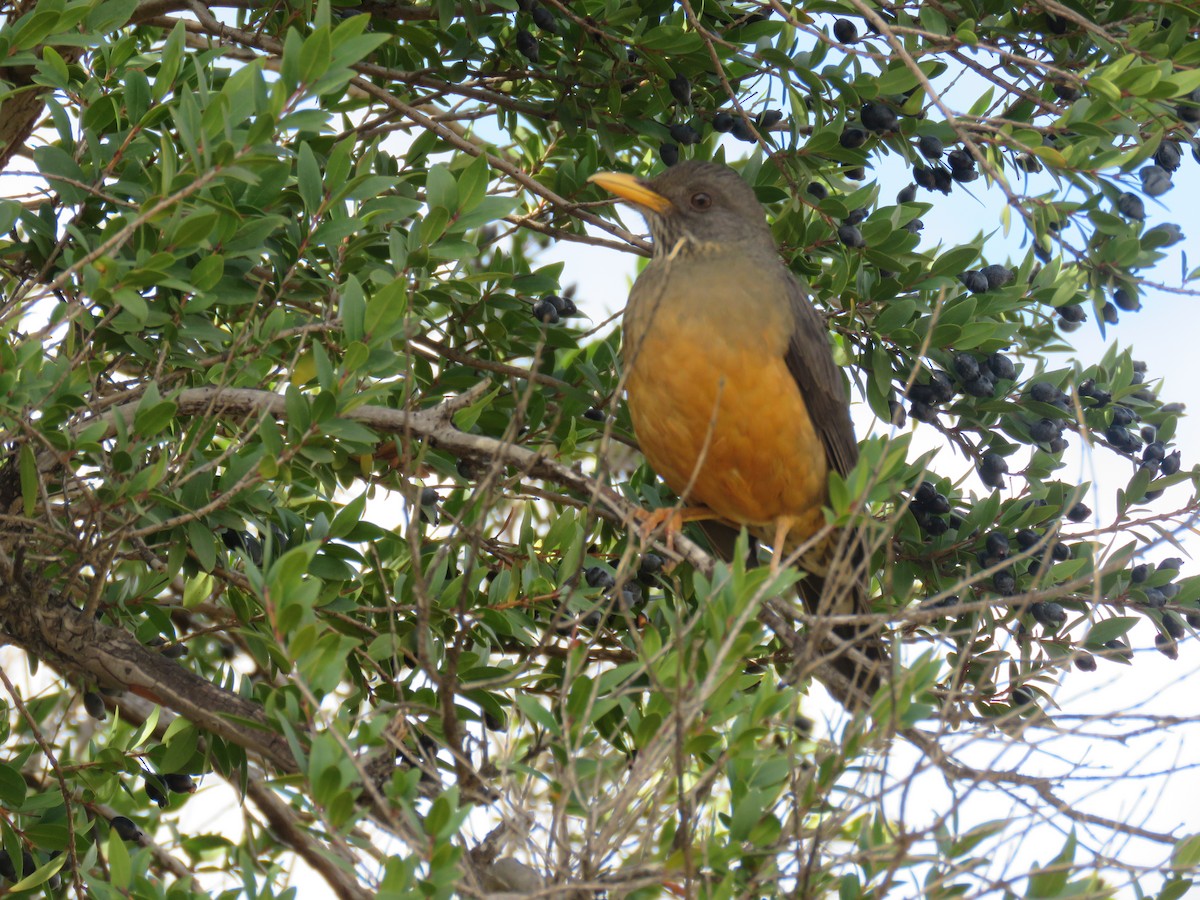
588,161,774,256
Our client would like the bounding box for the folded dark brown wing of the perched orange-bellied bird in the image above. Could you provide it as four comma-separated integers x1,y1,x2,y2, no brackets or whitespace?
785,271,858,475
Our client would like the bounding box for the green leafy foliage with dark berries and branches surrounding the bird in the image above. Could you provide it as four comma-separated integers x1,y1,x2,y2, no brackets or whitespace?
0,0,1200,898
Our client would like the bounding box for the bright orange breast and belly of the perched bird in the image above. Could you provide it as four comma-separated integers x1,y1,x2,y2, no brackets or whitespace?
625,302,828,539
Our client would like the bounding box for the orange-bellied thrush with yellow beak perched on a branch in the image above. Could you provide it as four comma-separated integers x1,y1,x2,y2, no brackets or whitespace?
589,161,886,697
